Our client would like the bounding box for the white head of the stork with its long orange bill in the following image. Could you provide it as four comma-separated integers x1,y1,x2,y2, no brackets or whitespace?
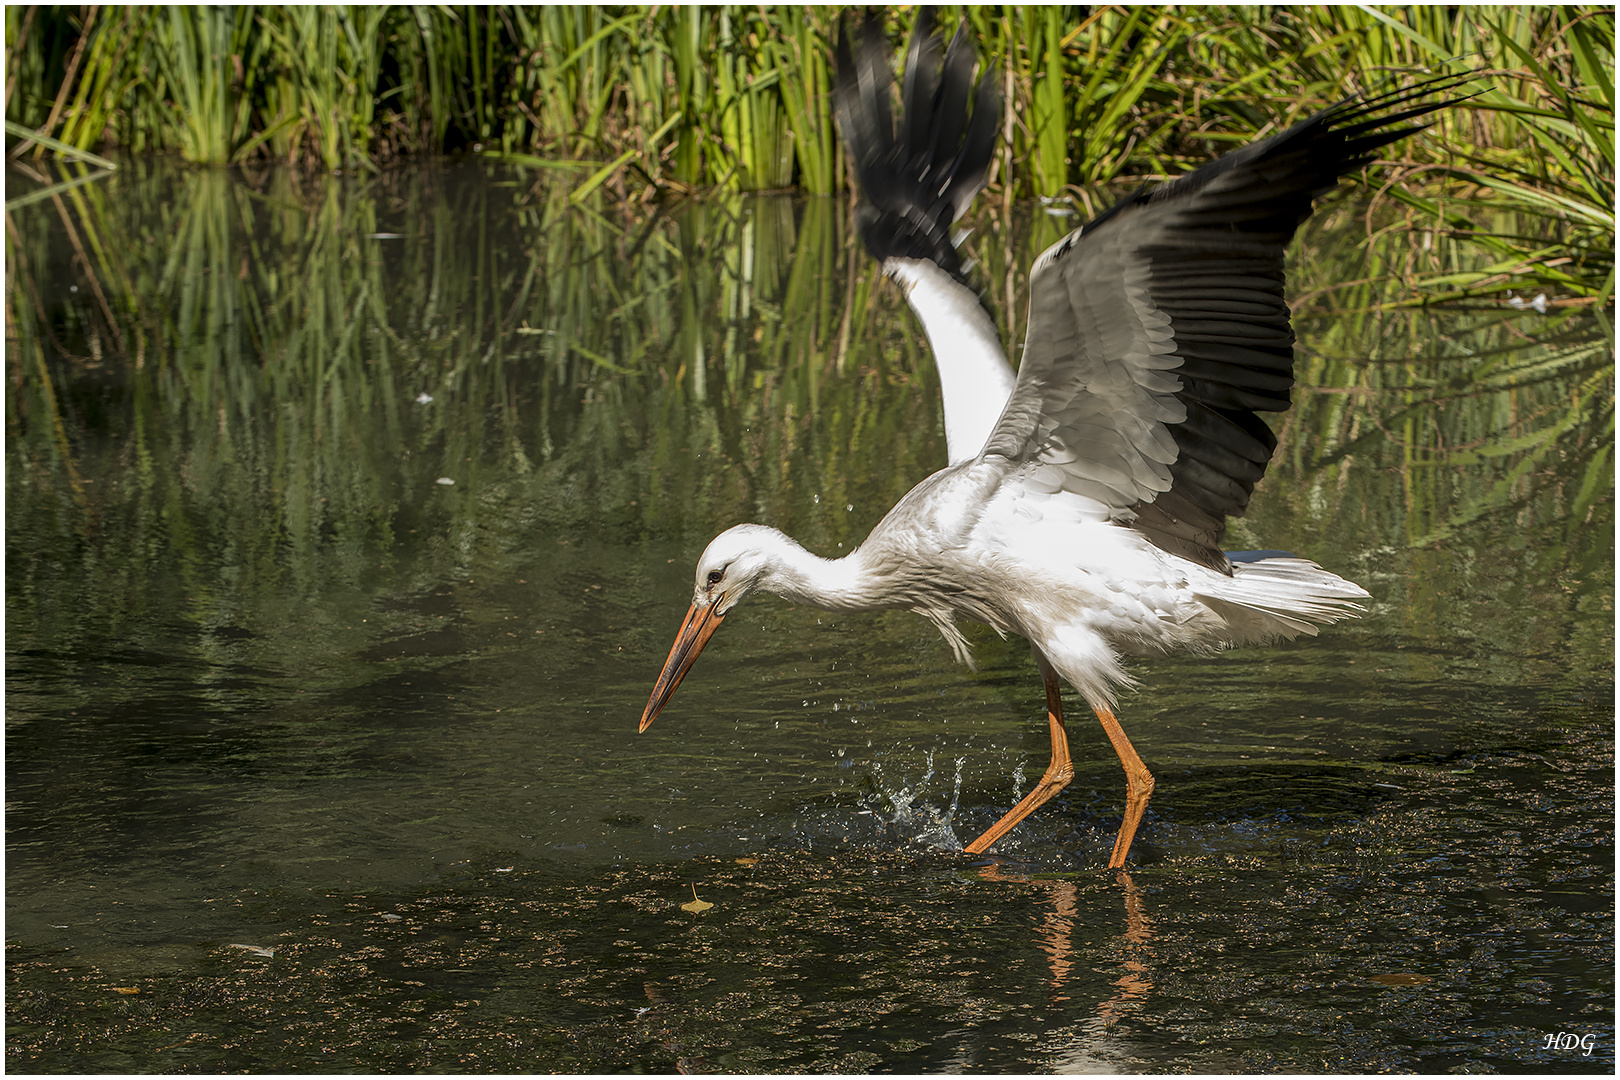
642,525,792,732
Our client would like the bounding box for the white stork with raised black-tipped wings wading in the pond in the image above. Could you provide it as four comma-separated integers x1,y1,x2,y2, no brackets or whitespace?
642,11,1458,866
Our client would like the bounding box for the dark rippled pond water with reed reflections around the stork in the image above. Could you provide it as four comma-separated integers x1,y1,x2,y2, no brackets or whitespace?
5,160,1615,1074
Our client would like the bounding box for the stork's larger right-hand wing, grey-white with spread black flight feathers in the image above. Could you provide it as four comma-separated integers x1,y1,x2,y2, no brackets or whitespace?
985,78,1463,573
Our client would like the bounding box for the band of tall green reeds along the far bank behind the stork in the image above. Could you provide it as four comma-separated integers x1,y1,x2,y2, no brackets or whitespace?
6,5,1614,208
